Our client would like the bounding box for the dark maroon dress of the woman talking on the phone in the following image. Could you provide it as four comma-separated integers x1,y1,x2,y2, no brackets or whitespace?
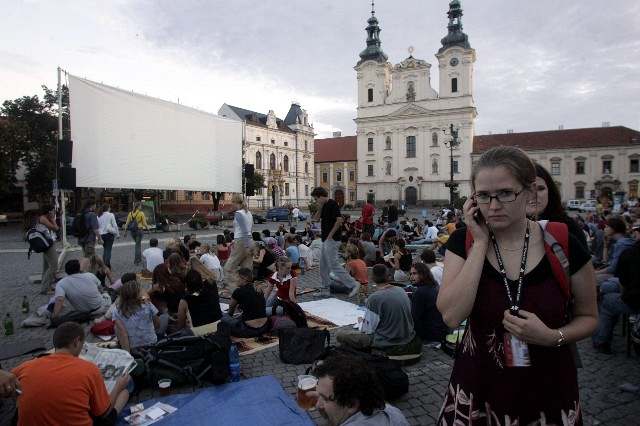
439,229,588,426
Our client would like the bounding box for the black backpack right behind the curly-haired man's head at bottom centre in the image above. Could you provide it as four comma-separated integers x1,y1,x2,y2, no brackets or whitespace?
307,346,409,401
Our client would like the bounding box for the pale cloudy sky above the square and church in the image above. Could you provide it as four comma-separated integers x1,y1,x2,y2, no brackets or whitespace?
0,0,640,137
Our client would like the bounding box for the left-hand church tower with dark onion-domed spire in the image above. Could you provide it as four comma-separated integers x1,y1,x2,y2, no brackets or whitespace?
354,2,391,108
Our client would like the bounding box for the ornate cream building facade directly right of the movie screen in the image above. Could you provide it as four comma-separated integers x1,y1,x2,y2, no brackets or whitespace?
218,103,314,209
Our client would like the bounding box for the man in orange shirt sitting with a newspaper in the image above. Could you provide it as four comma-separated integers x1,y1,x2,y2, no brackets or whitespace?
13,322,129,426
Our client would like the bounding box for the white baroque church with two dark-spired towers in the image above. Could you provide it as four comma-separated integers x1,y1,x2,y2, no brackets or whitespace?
354,0,476,205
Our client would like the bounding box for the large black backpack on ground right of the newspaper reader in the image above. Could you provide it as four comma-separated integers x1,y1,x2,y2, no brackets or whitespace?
135,334,231,386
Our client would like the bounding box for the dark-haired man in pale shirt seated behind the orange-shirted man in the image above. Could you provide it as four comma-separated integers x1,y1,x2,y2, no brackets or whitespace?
51,259,111,320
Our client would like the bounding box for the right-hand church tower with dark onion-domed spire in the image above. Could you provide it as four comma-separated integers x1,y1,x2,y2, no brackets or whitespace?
436,0,476,98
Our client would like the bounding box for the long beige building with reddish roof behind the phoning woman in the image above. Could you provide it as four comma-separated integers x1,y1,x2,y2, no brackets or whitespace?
470,126,640,202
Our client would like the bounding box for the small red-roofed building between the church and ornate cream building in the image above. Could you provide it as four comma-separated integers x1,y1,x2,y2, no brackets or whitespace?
315,133,358,206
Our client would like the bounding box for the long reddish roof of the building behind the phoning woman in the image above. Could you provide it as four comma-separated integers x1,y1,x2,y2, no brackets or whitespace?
473,126,640,154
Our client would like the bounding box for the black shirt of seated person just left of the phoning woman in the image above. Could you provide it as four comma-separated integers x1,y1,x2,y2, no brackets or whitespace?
411,285,449,342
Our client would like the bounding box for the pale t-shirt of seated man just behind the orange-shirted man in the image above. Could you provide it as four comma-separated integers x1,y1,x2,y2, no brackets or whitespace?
54,272,103,312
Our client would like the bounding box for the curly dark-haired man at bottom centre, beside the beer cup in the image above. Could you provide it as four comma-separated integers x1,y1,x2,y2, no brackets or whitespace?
314,356,409,426
